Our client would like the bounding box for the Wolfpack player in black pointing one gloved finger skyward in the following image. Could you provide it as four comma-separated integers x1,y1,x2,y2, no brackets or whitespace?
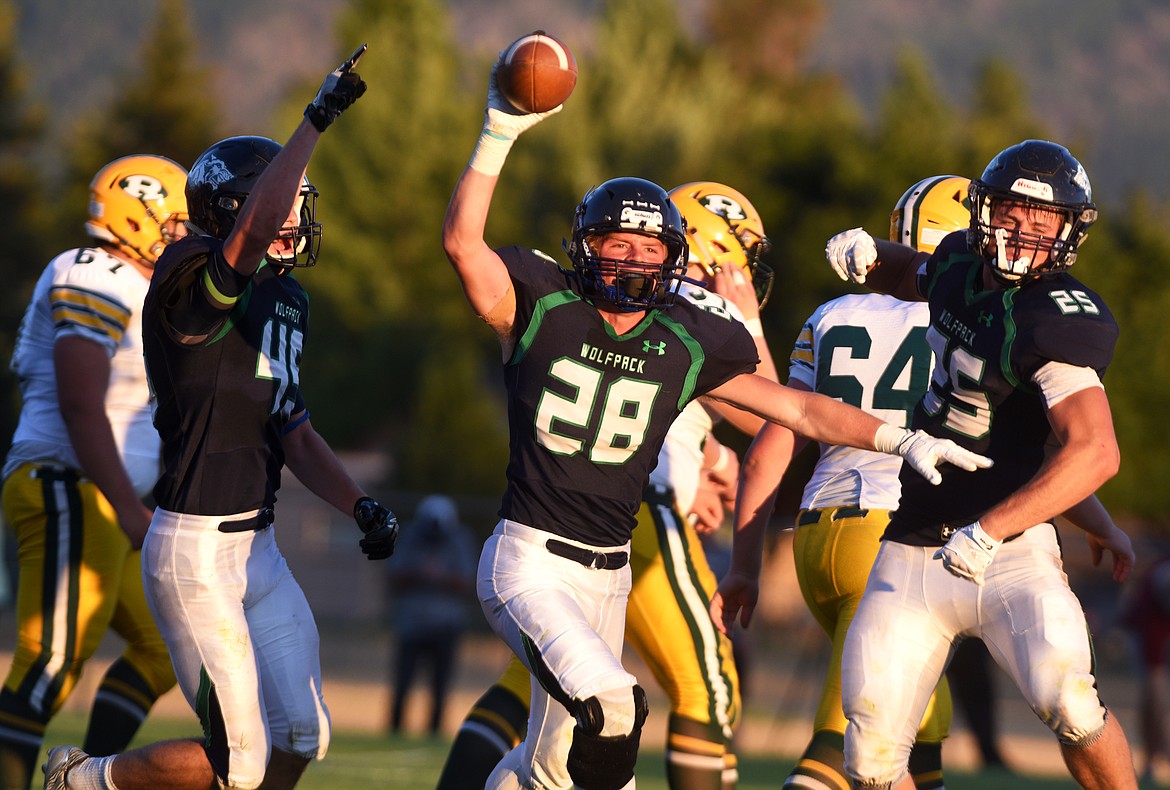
44,50,398,790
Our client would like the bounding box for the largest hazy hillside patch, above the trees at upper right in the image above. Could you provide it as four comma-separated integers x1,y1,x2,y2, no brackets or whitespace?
815,0,1170,202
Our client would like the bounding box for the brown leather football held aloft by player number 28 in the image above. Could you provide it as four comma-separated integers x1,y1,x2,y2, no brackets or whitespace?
496,30,577,112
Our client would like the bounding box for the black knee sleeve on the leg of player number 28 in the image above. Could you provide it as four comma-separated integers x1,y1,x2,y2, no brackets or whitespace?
567,686,649,790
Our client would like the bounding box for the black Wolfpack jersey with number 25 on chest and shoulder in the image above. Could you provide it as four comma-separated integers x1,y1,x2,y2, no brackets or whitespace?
886,233,1117,545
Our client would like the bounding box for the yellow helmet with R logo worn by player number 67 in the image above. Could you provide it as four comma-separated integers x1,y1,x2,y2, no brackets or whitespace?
85,154,188,266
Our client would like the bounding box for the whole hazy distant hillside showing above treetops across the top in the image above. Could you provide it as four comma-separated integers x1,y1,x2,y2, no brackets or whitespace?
16,0,1170,202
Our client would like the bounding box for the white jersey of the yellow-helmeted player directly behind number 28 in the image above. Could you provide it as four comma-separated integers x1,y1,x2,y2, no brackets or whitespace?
651,283,743,514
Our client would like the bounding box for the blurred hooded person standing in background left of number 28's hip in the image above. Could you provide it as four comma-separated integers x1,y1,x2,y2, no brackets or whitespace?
390,494,479,735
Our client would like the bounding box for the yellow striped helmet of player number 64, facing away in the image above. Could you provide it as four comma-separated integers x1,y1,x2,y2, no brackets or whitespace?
889,176,971,253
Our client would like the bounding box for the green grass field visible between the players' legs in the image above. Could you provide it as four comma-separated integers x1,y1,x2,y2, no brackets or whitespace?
37,712,1099,790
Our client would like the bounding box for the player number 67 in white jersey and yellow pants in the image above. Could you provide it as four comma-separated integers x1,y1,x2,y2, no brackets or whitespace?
0,154,187,788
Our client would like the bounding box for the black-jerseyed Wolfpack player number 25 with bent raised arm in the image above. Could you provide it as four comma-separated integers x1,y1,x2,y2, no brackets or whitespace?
826,139,1137,790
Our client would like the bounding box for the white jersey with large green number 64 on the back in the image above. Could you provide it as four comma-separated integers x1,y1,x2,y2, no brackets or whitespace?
789,294,932,510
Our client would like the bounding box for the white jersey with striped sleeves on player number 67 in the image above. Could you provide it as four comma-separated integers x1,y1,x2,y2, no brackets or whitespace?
4,248,161,496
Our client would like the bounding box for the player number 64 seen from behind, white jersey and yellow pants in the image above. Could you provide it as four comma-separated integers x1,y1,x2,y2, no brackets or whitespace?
715,176,970,790
